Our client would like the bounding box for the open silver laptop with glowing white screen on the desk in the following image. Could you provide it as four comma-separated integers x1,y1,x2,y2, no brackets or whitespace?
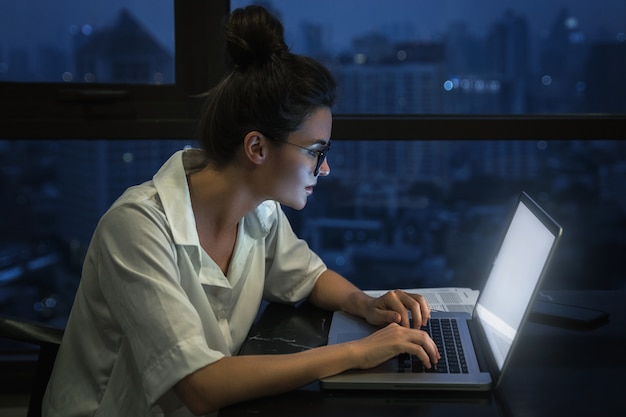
321,192,562,391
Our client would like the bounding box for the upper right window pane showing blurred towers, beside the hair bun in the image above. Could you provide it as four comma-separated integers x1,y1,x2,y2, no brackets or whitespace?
231,0,626,115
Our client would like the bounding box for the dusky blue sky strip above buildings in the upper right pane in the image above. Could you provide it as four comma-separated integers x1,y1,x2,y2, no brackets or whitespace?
231,0,626,52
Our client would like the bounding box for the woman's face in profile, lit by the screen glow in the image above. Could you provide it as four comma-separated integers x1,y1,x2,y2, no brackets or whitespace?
272,108,332,210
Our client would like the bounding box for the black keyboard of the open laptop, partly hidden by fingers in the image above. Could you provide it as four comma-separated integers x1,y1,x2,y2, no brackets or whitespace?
398,318,467,374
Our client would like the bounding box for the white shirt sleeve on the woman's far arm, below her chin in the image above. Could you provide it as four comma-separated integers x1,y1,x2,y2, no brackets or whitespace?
264,203,327,303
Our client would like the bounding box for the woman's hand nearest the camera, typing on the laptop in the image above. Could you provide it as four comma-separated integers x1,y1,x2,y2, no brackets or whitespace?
349,323,441,369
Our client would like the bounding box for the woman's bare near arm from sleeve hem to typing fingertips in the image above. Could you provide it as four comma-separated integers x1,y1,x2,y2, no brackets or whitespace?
174,318,439,415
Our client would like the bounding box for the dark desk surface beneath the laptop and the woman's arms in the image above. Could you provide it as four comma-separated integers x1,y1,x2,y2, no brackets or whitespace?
219,291,626,417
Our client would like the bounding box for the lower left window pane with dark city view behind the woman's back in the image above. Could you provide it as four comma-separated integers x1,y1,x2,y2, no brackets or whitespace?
0,140,192,332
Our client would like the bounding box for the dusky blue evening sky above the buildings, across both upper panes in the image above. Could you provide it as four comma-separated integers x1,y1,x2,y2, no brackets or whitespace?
0,0,626,63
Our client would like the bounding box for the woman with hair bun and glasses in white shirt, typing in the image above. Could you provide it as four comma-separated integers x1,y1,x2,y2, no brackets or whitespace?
44,6,439,417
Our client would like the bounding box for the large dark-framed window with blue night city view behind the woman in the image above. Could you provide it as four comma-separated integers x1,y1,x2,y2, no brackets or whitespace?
0,0,626,360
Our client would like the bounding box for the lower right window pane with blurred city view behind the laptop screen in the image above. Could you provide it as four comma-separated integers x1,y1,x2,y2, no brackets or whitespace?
288,138,626,289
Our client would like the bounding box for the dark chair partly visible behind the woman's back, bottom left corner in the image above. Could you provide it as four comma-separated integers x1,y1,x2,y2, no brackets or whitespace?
0,317,63,417
